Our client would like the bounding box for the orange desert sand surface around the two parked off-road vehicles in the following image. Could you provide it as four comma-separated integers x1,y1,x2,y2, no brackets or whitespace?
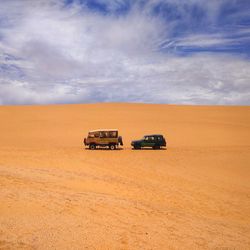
0,104,250,249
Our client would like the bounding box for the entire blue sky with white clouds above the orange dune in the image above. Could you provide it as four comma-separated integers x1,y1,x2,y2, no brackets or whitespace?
0,0,250,105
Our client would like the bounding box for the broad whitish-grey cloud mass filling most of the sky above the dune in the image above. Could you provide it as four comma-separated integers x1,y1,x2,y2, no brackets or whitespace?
0,0,250,104
